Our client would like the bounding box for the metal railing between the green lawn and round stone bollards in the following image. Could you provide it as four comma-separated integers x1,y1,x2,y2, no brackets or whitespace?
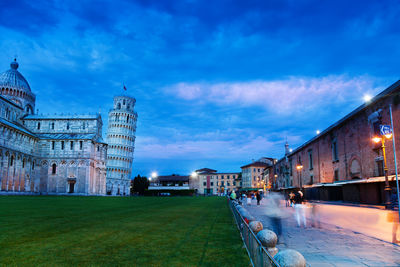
229,200,280,267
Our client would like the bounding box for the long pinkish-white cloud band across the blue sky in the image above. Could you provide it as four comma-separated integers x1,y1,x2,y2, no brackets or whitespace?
166,75,382,113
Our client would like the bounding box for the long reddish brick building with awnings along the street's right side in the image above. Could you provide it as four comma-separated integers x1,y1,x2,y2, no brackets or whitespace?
274,81,400,204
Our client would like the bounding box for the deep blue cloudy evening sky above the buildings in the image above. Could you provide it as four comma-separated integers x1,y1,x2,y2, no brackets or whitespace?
0,0,400,178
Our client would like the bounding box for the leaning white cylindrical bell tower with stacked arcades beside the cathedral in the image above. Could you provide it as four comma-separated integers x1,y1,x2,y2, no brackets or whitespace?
106,96,137,195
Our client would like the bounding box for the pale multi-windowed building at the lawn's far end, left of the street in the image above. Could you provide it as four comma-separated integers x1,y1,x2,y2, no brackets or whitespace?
190,168,241,195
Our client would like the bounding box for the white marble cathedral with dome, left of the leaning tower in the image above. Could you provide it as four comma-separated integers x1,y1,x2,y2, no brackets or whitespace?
0,60,107,195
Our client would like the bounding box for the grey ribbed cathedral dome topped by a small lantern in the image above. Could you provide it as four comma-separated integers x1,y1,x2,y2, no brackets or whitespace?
0,59,31,92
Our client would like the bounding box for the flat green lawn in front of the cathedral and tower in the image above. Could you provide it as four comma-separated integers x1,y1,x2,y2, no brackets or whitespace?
0,196,249,266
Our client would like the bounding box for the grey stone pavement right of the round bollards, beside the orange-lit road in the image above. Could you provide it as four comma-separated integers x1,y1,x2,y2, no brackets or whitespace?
244,200,400,267
